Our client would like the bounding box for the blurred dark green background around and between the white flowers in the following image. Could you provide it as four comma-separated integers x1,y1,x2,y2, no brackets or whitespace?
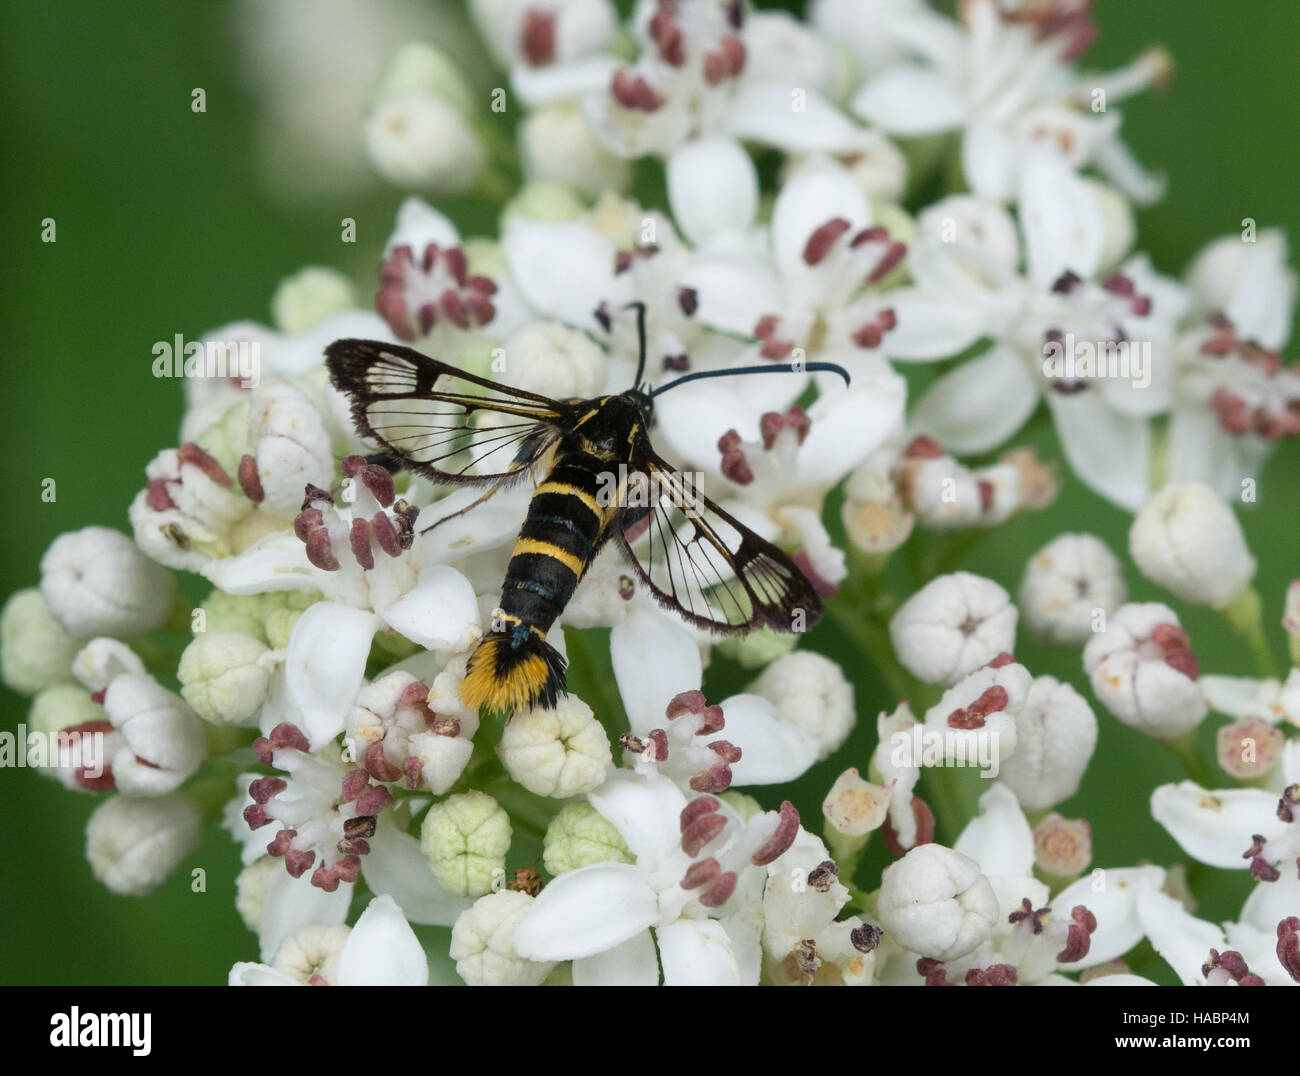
0,0,1300,984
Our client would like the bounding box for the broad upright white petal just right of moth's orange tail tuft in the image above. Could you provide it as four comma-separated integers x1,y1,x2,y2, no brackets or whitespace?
610,609,703,736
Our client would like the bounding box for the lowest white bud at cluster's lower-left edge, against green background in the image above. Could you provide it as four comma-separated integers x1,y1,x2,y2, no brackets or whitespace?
86,794,203,897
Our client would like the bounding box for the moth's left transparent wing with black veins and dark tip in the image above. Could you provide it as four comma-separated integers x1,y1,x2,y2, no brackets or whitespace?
325,339,566,483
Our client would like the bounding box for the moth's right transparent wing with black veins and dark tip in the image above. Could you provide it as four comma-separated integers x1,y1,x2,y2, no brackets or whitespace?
614,455,822,633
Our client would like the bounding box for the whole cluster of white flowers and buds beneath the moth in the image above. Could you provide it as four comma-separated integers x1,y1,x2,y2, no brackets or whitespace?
0,0,1300,985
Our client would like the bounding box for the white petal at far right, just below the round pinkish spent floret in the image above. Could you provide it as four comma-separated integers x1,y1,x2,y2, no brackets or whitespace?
1151,781,1287,871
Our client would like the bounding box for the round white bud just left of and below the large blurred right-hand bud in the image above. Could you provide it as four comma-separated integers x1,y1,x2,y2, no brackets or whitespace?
1017,534,1128,646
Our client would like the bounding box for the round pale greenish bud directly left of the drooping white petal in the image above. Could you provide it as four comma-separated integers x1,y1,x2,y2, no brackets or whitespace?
177,632,277,725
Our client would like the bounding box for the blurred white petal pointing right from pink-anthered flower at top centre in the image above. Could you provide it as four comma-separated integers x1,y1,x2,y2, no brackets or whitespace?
727,83,870,153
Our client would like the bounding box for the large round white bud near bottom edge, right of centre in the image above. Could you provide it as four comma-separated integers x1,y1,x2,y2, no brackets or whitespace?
876,845,998,960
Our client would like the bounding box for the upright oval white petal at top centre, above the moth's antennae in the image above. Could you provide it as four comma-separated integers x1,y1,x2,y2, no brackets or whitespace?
668,138,758,248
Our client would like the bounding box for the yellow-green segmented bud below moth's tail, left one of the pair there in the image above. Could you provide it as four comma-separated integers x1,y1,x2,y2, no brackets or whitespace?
420,791,511,897
